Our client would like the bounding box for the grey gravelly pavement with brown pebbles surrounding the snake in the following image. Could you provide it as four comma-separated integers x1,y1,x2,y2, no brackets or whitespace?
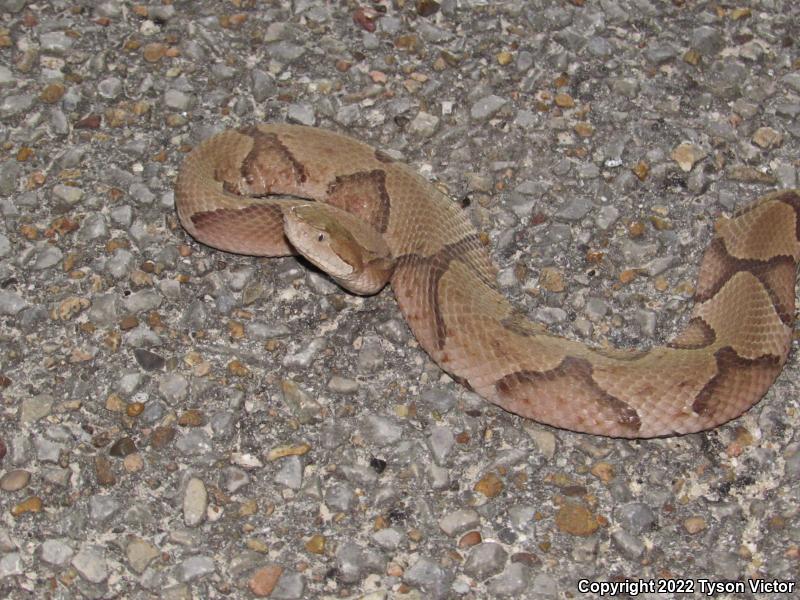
0,0,800,600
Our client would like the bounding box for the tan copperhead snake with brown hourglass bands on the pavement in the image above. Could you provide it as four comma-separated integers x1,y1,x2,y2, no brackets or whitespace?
175,125,800,438
